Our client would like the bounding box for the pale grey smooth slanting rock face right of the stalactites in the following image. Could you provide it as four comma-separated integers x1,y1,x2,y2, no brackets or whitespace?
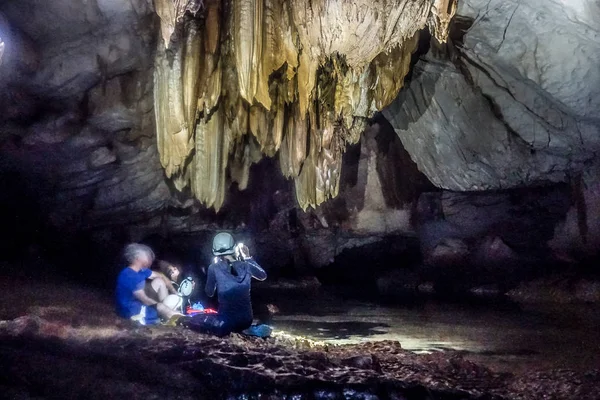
384,0,600,191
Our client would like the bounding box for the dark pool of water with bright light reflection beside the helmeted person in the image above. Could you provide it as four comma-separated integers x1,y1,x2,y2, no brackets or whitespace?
272,294,600,370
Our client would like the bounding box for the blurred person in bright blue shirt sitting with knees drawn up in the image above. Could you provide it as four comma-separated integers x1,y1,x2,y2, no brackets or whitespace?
116,243,181,325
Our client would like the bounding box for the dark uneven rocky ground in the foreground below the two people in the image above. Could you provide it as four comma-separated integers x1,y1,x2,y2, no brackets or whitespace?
0,278,600,399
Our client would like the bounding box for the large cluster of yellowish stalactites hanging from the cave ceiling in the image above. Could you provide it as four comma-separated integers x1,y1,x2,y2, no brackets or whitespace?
154,0,455,210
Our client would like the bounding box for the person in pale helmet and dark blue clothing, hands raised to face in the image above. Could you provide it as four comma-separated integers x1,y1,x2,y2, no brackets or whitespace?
188,232,267,336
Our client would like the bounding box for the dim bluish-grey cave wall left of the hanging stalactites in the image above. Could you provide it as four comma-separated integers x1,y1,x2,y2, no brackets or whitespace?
0,0,171,272
